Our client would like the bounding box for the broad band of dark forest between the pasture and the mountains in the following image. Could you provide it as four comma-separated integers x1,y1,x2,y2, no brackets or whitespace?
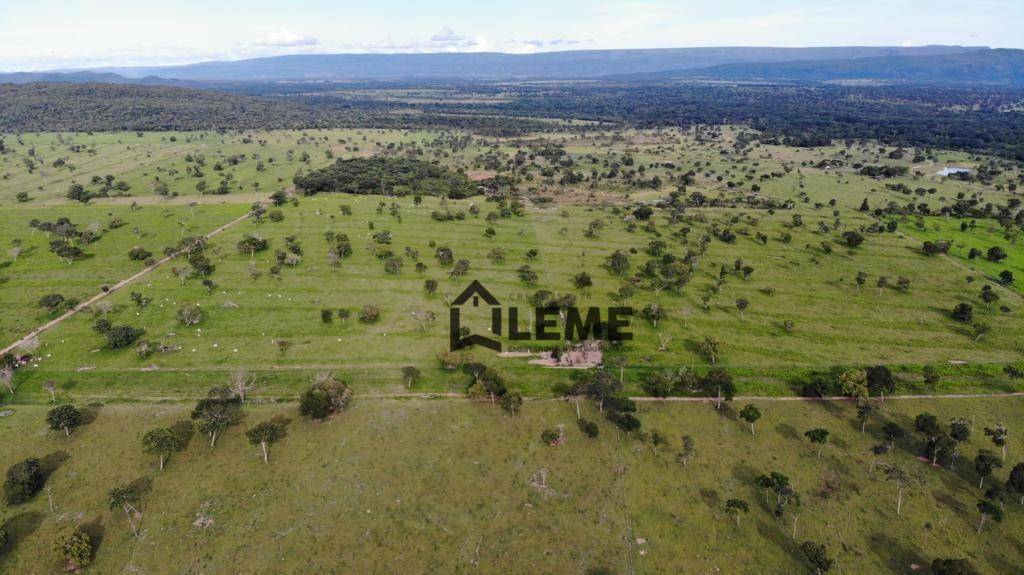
6,82,1024,160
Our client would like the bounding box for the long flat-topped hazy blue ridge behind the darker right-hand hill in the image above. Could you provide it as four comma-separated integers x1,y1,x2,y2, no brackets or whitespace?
75,46,980,82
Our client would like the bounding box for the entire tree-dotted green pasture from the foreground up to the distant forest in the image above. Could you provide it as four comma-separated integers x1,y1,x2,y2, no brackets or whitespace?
0,127,1024,574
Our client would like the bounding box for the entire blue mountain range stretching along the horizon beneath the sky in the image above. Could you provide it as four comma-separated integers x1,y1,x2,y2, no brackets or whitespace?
0,46,1007,86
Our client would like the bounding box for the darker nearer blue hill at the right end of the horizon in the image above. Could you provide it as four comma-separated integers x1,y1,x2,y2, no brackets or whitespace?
647,49,1024,86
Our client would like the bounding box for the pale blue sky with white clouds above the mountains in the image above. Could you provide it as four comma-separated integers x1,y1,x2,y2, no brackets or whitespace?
0,0,1024,71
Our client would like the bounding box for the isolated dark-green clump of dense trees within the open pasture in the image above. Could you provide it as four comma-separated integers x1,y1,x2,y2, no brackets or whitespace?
295,157,477,198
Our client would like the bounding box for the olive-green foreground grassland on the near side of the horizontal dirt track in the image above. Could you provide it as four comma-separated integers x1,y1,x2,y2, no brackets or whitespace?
0,396,1024,574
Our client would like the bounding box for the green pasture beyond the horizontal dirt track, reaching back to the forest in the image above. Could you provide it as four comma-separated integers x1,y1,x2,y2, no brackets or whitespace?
0,130,1024,401
